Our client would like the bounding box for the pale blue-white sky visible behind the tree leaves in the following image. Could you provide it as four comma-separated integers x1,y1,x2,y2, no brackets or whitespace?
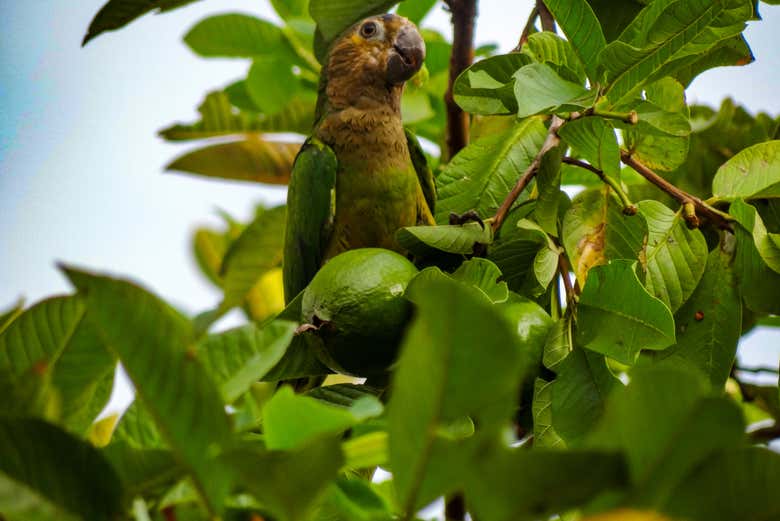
0,0,780,374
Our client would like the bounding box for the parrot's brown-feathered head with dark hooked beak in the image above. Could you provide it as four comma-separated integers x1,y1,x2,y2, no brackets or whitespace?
324,14,425,108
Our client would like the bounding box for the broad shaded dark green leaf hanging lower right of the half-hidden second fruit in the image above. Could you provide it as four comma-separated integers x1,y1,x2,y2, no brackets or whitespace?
551,349,620,446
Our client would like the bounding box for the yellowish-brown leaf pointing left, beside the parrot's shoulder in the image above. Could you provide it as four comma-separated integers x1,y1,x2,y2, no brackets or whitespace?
165,135,301,185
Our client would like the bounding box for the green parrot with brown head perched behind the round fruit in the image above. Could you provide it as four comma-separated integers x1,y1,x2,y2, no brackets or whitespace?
283,14,436,304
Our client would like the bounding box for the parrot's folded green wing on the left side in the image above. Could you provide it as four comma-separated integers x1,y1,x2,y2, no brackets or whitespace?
283,138,338,303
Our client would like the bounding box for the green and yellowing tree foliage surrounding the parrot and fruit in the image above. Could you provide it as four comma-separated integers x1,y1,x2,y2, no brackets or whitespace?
0,0,780,521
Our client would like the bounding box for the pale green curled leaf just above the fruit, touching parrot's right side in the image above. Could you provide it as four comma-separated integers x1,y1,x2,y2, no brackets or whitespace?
396,222,493,255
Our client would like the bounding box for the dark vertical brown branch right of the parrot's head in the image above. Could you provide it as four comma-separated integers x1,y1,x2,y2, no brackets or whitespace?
444,0,477,160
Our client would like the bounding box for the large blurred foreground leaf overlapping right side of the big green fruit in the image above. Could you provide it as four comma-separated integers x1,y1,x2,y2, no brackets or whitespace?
388,270,530,515
